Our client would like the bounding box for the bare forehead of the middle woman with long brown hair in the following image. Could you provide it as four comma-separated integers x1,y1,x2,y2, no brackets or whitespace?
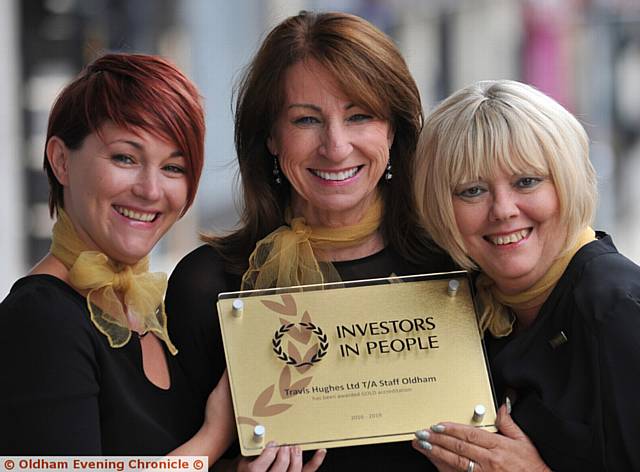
284,60,350,106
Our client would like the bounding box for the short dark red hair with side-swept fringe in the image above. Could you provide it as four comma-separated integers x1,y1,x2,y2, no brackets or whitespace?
44,53,205,216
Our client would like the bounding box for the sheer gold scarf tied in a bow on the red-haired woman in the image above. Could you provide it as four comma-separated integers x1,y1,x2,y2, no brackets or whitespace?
50,209,178,356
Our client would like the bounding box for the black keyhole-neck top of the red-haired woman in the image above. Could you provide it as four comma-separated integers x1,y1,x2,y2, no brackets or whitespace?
0,275,202,456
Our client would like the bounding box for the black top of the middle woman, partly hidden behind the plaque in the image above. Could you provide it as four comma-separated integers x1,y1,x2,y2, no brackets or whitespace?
166,242,455,471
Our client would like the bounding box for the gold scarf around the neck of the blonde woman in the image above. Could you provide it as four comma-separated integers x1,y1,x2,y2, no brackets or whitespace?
476,228,596,337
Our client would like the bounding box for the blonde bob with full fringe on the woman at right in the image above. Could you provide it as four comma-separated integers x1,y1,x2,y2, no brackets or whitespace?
415,80,597,269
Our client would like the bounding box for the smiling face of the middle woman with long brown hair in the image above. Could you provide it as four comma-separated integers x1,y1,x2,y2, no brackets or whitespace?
267,61,393,226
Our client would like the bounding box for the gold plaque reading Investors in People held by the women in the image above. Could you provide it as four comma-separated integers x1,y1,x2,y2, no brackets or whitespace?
218,272,496,456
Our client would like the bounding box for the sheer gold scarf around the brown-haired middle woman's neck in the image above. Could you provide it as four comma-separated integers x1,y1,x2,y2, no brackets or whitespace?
241,197,383,290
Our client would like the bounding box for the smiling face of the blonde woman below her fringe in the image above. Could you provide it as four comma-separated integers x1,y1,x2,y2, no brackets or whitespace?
453,171,567,293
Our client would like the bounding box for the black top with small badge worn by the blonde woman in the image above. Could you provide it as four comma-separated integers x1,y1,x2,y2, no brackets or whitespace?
487,233,640,471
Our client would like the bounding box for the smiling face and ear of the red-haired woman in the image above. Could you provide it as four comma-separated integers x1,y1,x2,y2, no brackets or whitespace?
47,123,188,264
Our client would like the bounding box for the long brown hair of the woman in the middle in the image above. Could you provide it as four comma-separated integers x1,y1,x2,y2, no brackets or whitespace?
210,11,440,274
